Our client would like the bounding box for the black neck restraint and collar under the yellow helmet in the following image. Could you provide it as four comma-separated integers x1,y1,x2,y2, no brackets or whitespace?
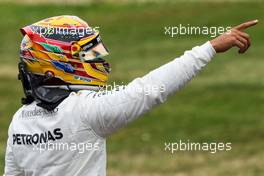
18,61,103,111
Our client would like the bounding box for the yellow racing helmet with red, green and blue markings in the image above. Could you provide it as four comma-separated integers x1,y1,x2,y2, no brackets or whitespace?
20,15,110,86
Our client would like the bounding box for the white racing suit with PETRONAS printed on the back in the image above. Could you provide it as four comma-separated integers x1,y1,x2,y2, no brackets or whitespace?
5,42,215,176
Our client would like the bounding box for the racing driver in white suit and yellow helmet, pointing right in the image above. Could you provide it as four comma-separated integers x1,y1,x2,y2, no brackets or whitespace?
5,15,258,176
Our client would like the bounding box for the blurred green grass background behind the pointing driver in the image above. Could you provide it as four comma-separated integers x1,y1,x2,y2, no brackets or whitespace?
0,0,264,176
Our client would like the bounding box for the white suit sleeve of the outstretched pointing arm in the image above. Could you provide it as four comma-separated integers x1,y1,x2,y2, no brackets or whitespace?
79,42,215,137
